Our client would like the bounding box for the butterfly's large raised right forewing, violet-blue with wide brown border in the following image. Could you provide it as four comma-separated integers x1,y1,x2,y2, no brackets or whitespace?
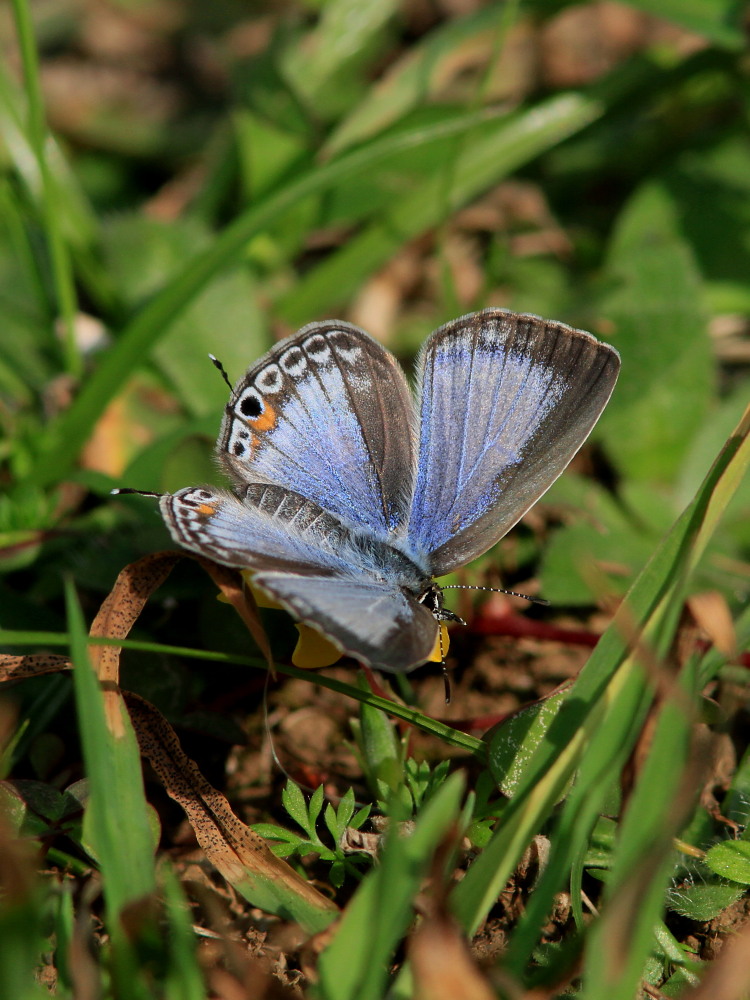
409,309,620,576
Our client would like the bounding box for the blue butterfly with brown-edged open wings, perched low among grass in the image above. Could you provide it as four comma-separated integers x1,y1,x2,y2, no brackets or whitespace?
160,309,620,671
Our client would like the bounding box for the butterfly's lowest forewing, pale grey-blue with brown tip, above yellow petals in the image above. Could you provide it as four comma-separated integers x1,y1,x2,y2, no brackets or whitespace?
253,573,438,672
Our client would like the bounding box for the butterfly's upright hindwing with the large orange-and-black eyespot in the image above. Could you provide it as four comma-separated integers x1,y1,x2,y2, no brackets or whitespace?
217,321,416,536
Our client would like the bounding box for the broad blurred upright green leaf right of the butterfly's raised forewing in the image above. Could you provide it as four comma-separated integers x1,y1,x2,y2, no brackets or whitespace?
599,183,716,482
